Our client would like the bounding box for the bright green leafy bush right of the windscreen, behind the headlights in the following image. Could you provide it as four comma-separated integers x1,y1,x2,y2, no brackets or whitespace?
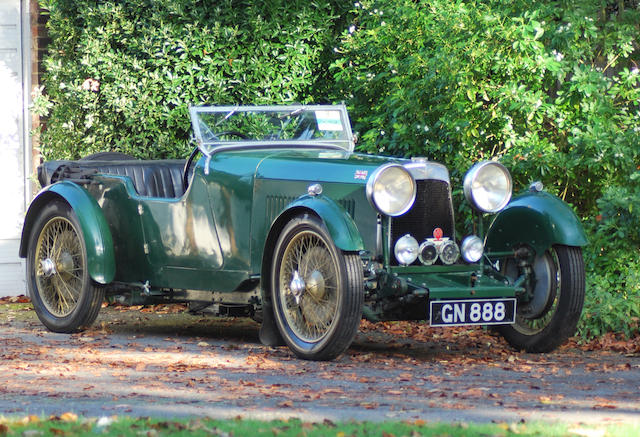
333,0,640,336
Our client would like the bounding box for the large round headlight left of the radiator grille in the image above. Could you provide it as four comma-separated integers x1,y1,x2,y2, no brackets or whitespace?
367,164,416,217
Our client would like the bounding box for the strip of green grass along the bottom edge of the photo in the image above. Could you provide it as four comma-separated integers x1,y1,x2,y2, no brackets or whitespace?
0,413,640,437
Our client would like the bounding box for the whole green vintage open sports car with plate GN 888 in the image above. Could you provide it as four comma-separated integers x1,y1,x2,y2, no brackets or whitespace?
20,105,587,360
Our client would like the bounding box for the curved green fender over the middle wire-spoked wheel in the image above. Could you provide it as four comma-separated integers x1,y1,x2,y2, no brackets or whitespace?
281,195,364,252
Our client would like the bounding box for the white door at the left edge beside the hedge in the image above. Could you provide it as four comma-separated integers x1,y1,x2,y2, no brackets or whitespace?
0,0,26,296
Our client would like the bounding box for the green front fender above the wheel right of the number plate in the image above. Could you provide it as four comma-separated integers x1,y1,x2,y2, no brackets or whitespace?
485,192,587,254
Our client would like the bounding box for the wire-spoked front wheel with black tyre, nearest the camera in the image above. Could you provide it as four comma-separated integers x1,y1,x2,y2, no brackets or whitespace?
271,215,364,360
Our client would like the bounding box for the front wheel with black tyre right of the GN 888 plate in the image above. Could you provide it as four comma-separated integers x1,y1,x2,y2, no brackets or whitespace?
497,246,585,352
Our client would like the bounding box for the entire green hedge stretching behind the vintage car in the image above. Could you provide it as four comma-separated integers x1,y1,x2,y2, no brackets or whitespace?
34,0,640,337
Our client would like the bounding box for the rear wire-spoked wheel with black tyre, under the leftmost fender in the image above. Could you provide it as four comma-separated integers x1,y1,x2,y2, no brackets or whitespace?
27,201,104,333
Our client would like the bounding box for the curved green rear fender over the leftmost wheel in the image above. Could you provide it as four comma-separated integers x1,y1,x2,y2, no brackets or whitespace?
20,181,116,284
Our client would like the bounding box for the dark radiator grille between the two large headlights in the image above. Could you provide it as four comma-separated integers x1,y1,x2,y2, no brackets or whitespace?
391,179,455,264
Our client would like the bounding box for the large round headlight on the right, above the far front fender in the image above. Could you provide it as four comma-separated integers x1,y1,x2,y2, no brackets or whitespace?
464,161,512,212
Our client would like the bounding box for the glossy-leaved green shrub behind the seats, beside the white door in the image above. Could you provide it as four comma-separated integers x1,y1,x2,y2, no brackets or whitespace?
34,0,350,158
